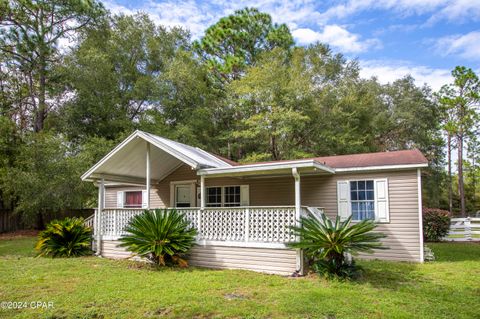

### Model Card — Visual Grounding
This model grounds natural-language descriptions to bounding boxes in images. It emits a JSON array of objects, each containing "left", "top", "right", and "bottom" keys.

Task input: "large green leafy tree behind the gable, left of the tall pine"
[{"left": 62, "top": 13, "right": 188, "bottom": 139}]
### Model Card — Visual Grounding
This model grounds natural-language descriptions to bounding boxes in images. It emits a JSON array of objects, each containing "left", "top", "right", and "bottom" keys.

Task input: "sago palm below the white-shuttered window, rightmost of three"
[{"left": 289, "top": 214, "right": 388, "bottom": 277}]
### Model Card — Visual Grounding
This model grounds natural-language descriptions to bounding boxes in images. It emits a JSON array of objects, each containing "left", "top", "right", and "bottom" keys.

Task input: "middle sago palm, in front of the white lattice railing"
[{"left": 120, "top": 209, "right": 197, "bottom": 267}]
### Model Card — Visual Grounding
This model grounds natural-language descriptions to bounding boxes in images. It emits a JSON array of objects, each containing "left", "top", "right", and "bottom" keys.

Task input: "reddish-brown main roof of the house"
[{"left": 213, "top": 149, "right": 428, "bottom": 168}]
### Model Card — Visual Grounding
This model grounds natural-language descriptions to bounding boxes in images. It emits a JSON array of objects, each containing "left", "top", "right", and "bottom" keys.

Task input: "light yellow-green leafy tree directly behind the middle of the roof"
[{"left": 230, "top": 49, "right": 311, "bottom": 161}]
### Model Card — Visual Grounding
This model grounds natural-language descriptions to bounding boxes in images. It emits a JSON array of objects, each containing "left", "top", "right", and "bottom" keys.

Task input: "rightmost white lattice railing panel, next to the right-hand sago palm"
[{"left": 248, "top": 207, "right": 296, "bottom": 243}]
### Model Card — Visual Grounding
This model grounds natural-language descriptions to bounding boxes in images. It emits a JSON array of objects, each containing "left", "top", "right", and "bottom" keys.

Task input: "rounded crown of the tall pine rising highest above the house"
[{"left": 194, "top": 8, "right": 294, "bottom": 83}]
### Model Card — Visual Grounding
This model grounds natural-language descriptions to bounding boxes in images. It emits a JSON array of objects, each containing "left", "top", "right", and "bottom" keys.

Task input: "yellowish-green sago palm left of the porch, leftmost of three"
[{"left": 35, "top": 217, "right": 92, "bottom": 257}]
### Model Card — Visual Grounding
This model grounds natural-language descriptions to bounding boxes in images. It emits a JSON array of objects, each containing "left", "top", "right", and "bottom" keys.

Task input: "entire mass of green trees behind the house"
[{"left": 0, "top": 0, "right": 480, "bottom": 226}]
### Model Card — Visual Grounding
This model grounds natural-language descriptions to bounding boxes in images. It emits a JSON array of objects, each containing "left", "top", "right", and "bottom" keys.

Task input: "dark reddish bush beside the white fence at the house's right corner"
[{"left": 423, "top": 207, "right": 450, "bottom": 241}]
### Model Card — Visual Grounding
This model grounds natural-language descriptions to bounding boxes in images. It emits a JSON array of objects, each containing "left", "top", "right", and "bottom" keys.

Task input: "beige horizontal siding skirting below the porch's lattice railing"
[{"left": 102, "top": 240, "right": 296, "bottom": 275}]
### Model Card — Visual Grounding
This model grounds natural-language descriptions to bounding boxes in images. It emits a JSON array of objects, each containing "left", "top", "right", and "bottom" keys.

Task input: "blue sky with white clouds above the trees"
[{"left": 103, "top": 0, "right": 480, "bottom": 90}]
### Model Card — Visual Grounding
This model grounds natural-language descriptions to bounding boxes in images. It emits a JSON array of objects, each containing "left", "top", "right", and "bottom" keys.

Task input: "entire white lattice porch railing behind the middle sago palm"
[{"left": 95, "top": 206, "right": 316, "bottom": 247}]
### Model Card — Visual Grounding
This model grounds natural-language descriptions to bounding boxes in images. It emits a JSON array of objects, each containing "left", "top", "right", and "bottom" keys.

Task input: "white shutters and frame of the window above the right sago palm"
[{"left": 337, "top": 177, "right": 390, "bottom": 224}]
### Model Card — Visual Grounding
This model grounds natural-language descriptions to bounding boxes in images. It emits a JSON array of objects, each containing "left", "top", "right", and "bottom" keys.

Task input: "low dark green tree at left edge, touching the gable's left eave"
[{"left": 0, "top": 131, "right": 113, "bottom": 229}]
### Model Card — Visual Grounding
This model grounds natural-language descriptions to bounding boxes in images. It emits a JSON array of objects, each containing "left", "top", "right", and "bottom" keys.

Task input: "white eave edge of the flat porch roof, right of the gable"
[{"left": 197, "top": 160, "right": 335, "bottom": 177}]
